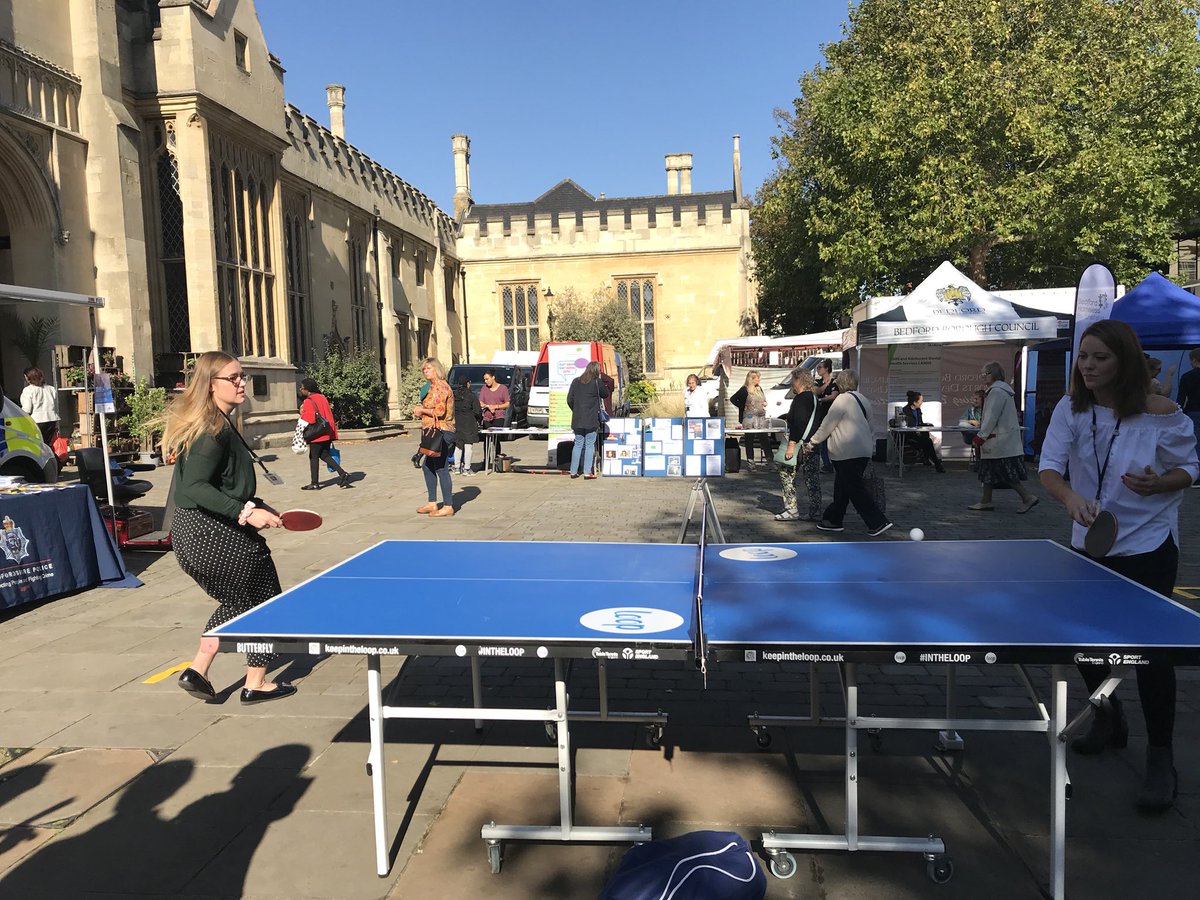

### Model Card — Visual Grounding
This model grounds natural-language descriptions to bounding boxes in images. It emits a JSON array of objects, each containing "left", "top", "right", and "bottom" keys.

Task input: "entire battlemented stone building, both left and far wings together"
[{"left": 0, "top": 0, "right": 752, "bottom": 442}]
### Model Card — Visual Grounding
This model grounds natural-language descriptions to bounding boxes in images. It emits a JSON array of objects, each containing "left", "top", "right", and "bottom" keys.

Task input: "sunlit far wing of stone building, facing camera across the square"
[{"left": 452, "top": 134, "right": 755, "bottom": 385}]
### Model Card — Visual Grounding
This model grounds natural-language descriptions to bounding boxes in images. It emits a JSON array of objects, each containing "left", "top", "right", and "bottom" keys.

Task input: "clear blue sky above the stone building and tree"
[{"left": 257, "top": 0, "right": 848, "bottom": 215}]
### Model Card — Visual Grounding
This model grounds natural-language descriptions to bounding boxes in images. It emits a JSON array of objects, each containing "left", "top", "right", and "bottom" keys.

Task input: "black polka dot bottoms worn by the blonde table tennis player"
[{"left": 170, "top": 509, "right": 281, "bottom": 668}]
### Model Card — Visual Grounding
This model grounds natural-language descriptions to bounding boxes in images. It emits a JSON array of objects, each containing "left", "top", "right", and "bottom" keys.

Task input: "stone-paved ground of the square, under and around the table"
[{"left": 0, "top": 437, "right": 1200, "bottom": 900}]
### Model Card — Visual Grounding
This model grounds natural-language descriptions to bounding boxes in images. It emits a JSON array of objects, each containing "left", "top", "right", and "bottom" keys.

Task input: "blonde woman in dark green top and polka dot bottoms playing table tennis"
[{"left": 162, "top": 350, "right": 295, "bottom": 703}]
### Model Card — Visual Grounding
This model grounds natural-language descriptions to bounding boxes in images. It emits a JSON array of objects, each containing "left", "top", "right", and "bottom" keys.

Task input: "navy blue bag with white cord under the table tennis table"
[{"left": 599, "top": 832, "right": 767, "bottom": 900}]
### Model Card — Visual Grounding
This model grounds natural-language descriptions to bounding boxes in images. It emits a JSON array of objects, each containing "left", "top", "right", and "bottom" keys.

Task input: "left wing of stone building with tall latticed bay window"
[{"left": 0, "top": 0, "right": 466, "bottom": 438}]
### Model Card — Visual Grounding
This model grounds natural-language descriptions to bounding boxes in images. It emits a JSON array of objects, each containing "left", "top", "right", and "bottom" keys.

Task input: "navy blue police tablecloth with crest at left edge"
[{"left": 0, "top": 485, "right": 142, "bottom": 610}]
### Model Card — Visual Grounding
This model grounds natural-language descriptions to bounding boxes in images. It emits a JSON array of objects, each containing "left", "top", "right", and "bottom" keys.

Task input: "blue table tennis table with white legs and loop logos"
[{"left": 206, "top": 528, "right": 1200, "bottom": 898}]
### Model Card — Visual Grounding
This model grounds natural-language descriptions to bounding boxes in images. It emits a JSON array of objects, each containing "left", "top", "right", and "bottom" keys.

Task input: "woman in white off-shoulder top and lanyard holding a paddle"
[{"left": 1040, "top": 319, "right": 1200, "bottom": 811}]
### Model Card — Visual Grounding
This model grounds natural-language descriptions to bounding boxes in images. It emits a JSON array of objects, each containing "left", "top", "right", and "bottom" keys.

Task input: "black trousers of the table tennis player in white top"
[{"left": 1079, "top": 535, "right": 1180, "bottom": 746}]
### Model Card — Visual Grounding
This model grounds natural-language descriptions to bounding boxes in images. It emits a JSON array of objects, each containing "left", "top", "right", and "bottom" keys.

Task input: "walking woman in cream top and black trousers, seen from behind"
[{"left": 804, "top": 368, "right": 892, "bottom": 538}]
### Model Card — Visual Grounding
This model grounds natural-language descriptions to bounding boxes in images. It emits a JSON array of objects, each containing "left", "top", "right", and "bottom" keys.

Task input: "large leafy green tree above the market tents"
[{"left": 754, "top": 0, "right": 1200, "bottom": 312}]
